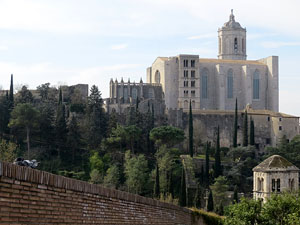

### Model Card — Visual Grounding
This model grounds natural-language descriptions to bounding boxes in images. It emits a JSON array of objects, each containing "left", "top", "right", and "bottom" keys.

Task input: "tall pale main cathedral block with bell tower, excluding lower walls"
[{"left": 147, "top": 12, "right": 279, "bottom": 112}]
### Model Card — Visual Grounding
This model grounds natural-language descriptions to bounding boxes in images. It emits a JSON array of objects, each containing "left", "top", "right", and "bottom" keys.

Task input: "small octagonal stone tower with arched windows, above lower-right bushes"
[{"left": 253, "top": 155, "right": 299, "bottom": 202}]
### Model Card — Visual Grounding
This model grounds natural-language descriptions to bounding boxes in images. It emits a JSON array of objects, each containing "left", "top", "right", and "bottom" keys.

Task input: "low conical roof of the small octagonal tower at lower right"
[{"left": 253, "top": 155, "right": 299, "bottom": 172}]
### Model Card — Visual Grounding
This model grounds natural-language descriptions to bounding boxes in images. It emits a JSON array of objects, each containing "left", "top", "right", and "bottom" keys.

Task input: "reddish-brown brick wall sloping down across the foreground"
[{"left": 0, "top": 162, "right": 204, "bottom": 225}]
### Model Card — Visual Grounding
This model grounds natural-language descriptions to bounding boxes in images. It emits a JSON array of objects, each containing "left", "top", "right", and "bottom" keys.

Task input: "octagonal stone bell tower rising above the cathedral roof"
[{"left": 218, "top": 10, "right": 247, "bottom": 60}]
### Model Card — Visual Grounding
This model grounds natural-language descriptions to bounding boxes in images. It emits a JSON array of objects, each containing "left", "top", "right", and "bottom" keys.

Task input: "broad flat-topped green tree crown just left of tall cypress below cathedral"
[{"left": 150, "top": 126, "right": 185, "bottom": 147}]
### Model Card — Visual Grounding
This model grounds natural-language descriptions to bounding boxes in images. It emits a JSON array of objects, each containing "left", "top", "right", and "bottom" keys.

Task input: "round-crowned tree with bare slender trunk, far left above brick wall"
[{"left": 9, "top": 103, "right": 39, "bottom": 159}]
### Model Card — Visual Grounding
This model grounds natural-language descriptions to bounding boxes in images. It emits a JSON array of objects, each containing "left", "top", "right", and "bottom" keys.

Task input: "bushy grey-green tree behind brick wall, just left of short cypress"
[{"left": 125, "top": 151, "right": 149, "bottom": 194}]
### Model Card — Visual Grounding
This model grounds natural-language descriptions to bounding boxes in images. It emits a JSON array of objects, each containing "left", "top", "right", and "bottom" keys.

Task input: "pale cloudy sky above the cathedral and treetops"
[{"left": 0, "top": 0, "right": 300, "bottom": 116}]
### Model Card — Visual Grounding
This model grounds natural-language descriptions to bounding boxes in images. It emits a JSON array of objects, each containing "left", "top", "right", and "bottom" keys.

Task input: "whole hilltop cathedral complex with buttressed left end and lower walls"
[{"left": 106, "top": 11, "right": 300, "bottom": 149}]
